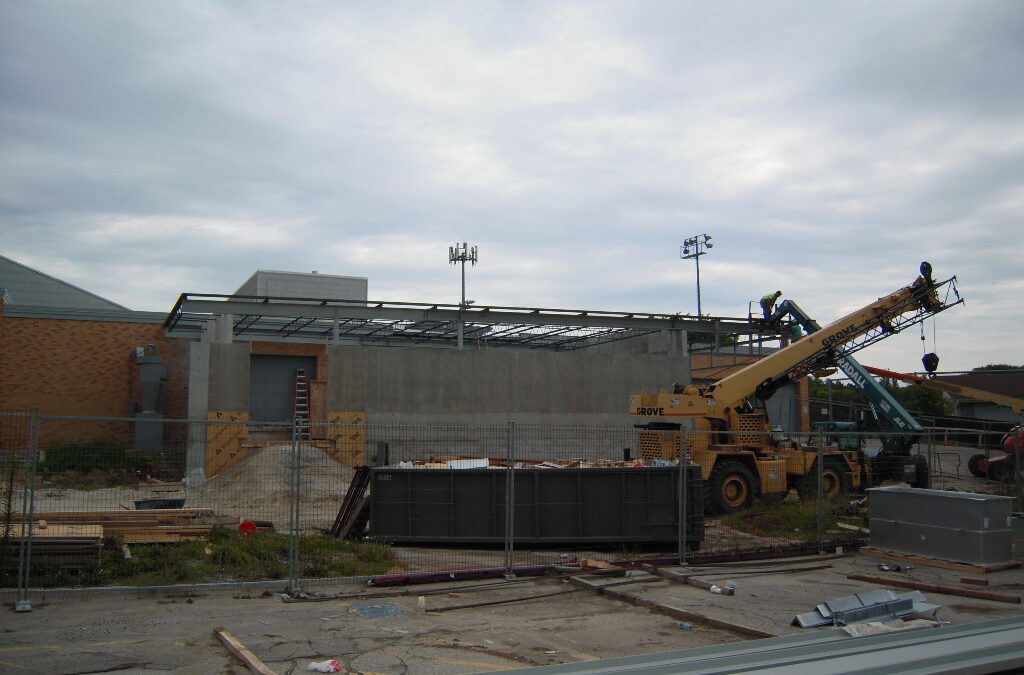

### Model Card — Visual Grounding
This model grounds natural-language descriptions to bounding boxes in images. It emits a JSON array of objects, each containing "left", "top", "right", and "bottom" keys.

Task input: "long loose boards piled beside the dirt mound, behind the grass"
[{"left": 14, "top": 509, "right": 216, "bottom": 544}]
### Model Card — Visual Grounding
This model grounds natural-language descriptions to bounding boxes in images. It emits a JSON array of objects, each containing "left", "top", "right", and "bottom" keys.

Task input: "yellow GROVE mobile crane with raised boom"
[{"left": 630, "top": 262, "right": 963, "bottom": 512}]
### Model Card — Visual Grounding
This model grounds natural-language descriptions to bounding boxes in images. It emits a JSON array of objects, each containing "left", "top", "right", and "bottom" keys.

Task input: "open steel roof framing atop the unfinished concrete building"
[{"left": 164, "top": 293, "right": 772, "bottom": 350}]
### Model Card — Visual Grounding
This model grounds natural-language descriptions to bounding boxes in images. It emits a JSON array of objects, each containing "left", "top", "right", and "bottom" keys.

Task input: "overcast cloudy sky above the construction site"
[{"left": 0, "top": 0, "right": 1024, "bottom": 371}]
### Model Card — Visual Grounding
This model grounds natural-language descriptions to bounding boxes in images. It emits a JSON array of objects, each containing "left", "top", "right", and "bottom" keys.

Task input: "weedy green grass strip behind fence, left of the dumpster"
[{"left": 14, "top": 526, "right": 395, "bottom": 588}]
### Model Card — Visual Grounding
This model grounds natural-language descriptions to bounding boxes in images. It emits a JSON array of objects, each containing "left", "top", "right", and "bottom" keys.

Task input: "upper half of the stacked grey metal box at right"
[{"left": 867, "top": 487, "right": 1014, "bottom": 531}]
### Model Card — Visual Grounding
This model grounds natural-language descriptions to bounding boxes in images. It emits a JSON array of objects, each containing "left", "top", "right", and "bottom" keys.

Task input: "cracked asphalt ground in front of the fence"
[{"left": 0, "top": 554, "right": 1024, "bottom": 675}]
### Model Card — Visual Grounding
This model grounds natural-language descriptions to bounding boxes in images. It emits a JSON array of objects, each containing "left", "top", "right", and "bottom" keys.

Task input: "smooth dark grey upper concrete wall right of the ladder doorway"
[{"left": 327, "top": 345, "right": 689, "bottom": 425}]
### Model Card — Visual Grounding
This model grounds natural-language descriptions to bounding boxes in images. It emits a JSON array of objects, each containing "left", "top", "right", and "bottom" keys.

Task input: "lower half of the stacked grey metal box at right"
[{"left": 870, "top": 518, "right": 1012, "bottom": 564}]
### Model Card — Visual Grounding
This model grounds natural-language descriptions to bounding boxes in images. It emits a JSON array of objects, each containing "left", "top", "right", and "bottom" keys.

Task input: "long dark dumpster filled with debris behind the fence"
[{"left": 370, "top": 466, "right": 703, "bottom": 550}]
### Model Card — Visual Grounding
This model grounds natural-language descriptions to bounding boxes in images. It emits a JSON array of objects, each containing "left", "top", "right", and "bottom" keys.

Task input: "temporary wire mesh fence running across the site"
[{"left": 0, "top": 412, "right": 1024, "bottom": 601}]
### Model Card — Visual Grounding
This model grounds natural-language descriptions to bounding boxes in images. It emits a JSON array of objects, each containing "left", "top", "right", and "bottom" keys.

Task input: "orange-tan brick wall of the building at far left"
[{"left": 0, "top": 314, "right": 188, "bottom": 447}]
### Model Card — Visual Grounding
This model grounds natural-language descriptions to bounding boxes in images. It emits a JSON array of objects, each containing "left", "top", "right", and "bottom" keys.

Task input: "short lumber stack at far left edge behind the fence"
[{"left": 0, "top": 521, "right": 103, "bottom": 569}]
